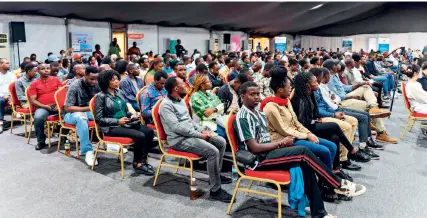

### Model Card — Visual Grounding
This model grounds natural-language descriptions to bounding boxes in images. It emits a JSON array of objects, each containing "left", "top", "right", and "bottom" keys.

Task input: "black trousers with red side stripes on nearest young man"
[{"left": 256, "top": 146, "right": 341, "bottom": 217}]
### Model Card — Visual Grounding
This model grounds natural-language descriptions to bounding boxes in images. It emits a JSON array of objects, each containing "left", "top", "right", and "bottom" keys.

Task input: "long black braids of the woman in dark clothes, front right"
[{"left": 291, "top": 72, "right": 319, "bottom": 127}]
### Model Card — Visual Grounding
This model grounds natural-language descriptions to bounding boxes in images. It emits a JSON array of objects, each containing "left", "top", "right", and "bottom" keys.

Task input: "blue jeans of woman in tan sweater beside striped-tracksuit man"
[{"left": 294, "top": 138, "right": 337, "bottom": 168}]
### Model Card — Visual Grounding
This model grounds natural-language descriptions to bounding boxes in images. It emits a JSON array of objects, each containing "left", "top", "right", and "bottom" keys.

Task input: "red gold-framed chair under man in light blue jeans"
[{"left": 55, "top": 86, "right": 95, "bottom": 159}]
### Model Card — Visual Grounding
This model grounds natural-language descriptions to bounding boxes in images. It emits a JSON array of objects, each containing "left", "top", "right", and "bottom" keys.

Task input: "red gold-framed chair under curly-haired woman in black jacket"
[{"left": 89, "top": 96, "right": 134, "bottom": 179}]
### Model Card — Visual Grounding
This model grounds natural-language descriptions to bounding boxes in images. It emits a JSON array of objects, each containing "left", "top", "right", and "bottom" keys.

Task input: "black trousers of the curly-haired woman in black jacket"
[{"left": 104, "top": 125, "right": 154, "bottom": 163}]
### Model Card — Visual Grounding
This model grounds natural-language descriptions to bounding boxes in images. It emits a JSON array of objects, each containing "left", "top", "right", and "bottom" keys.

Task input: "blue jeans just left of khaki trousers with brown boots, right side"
[{"left": 338, "top": 108, "right": 371, "bottom": 142}]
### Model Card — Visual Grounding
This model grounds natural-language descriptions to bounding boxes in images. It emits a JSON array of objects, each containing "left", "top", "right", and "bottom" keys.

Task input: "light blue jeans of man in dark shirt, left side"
[{"left": 64, "top": 111, "right": 93, "bottom": 155}]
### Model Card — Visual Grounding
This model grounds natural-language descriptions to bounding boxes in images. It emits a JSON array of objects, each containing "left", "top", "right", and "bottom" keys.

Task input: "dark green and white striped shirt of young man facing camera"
[{"left": 234, "top": 105, "right": 271, "bottom": 152}]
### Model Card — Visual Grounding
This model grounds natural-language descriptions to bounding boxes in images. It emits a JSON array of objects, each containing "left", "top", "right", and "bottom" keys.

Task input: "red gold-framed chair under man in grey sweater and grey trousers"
[{"left": 152, "top": 99, "right": 201, "bottom": 186}]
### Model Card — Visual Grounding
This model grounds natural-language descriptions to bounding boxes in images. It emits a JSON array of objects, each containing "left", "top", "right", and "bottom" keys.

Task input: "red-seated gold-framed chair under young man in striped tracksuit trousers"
[{"left": 226, "top": 114, "right": 290, "bottom": 218}]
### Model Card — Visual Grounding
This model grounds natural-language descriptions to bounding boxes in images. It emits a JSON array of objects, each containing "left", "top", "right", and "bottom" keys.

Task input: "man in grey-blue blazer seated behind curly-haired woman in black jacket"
[{"left": 120, "top": 62, "right": 144, "bottom": 111}]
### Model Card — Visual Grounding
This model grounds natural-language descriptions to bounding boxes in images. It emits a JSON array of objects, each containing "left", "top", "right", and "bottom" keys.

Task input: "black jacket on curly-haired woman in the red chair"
[{"left": 95, "top": 89, "right": 131, "bottom": 133}]
